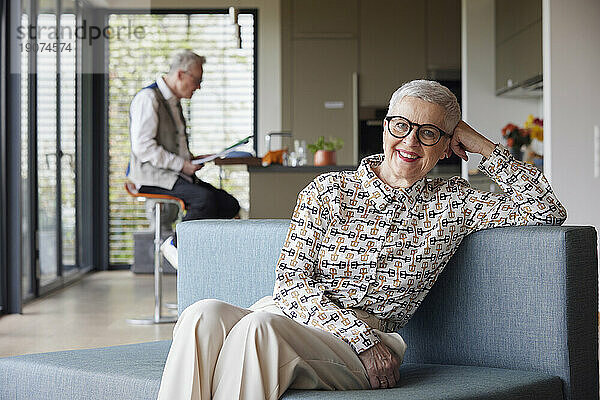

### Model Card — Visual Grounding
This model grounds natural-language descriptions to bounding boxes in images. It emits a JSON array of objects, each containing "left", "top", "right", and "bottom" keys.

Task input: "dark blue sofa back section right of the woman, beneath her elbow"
[{"left": 400, "top": 227, "right": 598, "bottom": 399}]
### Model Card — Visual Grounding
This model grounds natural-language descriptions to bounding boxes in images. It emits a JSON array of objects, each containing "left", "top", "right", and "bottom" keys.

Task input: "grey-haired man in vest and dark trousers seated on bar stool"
[{"left": 127, "top": 50, "right": 240, "bottom": 261}]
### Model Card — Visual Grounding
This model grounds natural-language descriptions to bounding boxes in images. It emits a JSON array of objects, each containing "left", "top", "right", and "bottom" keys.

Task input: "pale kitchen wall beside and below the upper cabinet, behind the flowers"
[{"left": 461, "top": 0, "right": 542, "bottom": 178}]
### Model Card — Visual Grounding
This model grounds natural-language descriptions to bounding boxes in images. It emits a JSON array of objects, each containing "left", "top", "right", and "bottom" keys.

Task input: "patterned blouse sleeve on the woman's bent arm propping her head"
[{"left": 460, "top": 145, "right": 567, "bottom": 232}]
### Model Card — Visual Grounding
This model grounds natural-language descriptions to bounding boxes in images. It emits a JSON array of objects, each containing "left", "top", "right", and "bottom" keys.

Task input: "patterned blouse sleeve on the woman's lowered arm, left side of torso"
[{"left": 273, "top": 181, "right": 379, "bottom": 353}]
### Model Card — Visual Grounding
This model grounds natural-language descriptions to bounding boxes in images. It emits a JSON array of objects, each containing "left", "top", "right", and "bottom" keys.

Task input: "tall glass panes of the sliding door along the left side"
[{"left": 21, "top": 0, "right": 79, "bottom": 298}]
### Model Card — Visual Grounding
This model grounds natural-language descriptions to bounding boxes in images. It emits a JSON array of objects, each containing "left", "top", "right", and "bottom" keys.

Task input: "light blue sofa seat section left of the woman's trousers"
[{"left": 0, "top": 340, "right": 171, "bottom": 400}]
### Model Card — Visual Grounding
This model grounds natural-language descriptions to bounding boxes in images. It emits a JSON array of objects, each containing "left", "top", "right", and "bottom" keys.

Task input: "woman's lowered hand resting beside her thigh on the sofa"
[{"left": 358, "top": 342, "right": 400, "bottom": 389}]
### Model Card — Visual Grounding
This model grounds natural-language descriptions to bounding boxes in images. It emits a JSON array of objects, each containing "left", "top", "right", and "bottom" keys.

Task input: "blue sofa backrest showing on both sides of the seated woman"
[{"left": 177, "top": 220, "right": 598, "bottom": 399}]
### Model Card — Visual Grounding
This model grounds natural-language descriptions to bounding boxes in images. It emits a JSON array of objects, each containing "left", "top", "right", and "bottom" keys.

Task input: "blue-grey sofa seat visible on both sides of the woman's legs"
[{"left": 0, "top": 341, "right": 563, "bottom": 400}]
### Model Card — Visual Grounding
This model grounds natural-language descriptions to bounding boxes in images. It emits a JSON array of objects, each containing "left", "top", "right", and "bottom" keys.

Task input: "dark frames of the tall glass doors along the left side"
[{"left": 0, "top": 0, "right": 97, "bottom": 314}]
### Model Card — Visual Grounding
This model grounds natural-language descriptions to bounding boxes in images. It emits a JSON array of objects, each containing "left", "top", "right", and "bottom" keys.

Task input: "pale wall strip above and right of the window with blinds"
[{"left": 102, "top": 0, "right": 282, "bottom": 155}]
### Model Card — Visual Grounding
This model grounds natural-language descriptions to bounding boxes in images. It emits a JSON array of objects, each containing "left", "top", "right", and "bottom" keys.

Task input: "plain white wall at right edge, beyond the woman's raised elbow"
[{"left": 542, "top": 0, "right": 600, "bottom": 244}]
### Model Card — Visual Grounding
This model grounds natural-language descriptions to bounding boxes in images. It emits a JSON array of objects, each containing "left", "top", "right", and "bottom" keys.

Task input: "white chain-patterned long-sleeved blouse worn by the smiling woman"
[{"left": 273, "top": 145, "right": 567, "bottom": 353}]
